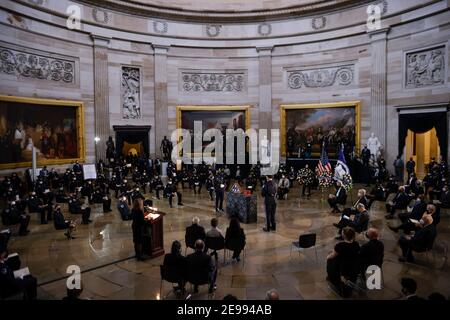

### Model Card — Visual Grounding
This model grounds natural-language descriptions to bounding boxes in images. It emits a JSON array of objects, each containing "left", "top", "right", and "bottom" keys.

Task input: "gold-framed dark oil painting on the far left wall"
[{"left": 0, "top": 95, "right": 85, "bottom": 169}]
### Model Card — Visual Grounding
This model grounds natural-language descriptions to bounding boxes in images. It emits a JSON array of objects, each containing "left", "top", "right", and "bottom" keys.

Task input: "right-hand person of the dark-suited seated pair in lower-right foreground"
[{"left": 359, "top": 228, "right": 384, "bottom": 276}]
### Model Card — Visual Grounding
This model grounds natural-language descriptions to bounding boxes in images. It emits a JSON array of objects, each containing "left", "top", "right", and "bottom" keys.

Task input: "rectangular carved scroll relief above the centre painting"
[{"left": 181, "top": 72, "right": 245, "bottom": 92}]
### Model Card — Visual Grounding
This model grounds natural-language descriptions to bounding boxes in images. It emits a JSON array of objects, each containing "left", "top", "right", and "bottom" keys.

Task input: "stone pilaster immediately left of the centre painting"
[{"left": 153, "top": 45, "right": 170, "bottom": 156}]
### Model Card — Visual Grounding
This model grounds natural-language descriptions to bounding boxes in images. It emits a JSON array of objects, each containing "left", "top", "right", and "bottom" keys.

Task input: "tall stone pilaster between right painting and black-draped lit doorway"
[{"left": 368, "top": 28, "right": 389, "bottom": 151}]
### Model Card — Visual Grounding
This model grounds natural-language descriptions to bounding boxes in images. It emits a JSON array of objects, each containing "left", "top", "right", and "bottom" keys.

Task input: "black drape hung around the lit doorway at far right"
[{"left": 398, "top": 112, "right": 448, "bottom": 159}]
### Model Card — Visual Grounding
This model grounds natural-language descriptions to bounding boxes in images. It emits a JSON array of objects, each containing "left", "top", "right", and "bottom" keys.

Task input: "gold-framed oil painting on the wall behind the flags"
[{"left": 280, "top": 101, "right": 361, "bottom": 158}]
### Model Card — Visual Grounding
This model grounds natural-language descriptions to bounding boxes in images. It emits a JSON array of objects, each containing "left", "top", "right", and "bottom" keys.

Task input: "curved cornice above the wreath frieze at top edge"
[{"left": 79, "top": 0, "right": 373, "bottom": 21}]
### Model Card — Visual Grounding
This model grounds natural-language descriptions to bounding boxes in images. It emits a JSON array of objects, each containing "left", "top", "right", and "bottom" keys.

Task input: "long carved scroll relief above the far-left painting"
[{"left": 0, "top": 47, "right": 75, "bottom": 83}]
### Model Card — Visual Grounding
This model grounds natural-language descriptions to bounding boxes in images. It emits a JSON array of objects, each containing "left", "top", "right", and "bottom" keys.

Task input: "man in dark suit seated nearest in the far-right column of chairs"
[{"left": 399, "top": 215, "right": 436, "bottom": 262}]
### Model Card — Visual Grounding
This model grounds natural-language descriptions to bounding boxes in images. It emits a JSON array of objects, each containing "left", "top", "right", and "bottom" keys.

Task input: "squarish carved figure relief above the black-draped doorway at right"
[{"left": 405, "top": 45, "right": 447, "bottom": 89}]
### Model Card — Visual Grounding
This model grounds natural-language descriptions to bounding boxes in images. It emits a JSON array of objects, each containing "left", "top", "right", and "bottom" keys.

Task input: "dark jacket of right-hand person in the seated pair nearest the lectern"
[{"left": 186, "top": 251, "right": 215, "bottom": 284}]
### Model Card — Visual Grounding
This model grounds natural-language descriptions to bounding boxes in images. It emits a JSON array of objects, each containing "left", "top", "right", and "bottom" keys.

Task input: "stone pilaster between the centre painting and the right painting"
[{"left": 256, "top": 47, "right": 273, "bottom": 134}]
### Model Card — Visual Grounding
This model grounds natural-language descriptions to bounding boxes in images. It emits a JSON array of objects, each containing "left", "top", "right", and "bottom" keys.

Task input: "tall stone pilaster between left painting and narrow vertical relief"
[{"left": 90, "top": 35, "right": 110, "bottom": 161}]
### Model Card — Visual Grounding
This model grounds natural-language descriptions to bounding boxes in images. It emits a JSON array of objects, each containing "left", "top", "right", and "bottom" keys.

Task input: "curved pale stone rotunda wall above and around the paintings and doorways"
[{"left": 0, "top": 0, "right": 450, "bottom": 172}]
